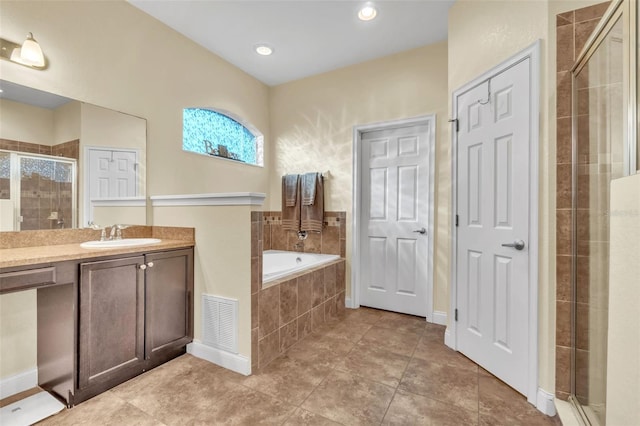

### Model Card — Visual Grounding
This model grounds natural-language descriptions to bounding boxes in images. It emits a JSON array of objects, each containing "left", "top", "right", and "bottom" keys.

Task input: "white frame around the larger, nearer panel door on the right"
[{"left": 445, "top": 40, "right": 548, "bottom": 411}]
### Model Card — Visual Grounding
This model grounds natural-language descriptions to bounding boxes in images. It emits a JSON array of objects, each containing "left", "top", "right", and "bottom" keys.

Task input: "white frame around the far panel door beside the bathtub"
[{"left": 346, "top": 114, "right": 437, "bottom": 322}]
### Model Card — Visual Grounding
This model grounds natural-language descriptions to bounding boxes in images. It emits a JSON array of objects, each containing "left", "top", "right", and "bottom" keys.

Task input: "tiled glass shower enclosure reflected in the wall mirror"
[{"left": 0, "top": 151, "right": 77, "bottom": 231}]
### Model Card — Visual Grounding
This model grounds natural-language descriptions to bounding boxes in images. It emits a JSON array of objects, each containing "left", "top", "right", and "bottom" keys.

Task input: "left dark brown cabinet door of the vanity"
[{"left": 78, "top": 256, "right": 144, "bottom": 389}]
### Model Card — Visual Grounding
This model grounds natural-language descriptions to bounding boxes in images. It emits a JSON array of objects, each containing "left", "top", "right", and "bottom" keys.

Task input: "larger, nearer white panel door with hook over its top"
[{"left": 456, "top": 59, "right": 535, "bottom": 394}]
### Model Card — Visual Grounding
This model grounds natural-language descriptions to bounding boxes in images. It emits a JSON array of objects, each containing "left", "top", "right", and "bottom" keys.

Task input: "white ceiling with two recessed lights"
[{"left": 129, "top": 0, "right": 455, "bottom": 86}]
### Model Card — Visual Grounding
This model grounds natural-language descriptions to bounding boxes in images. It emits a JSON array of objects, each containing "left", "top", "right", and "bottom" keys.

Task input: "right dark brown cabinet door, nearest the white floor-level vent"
[{"left": 145, "top": 249, "right": 193, "bottom": 359}]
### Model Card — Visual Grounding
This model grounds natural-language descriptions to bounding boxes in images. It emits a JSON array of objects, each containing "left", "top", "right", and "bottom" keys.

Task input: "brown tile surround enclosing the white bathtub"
[{"left": 251, "top": 211, "right": 346, "bottom": 372}]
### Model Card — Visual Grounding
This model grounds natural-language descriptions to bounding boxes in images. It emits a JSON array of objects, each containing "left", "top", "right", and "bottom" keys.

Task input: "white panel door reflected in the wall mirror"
[{"left": 89, "top": 149, "right": 137, "bottom": 200}]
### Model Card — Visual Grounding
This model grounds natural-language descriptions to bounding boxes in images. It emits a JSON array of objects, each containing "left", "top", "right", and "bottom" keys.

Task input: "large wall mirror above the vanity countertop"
[{"left": 0, "top": 80, "right": 147, "bottom": 231}]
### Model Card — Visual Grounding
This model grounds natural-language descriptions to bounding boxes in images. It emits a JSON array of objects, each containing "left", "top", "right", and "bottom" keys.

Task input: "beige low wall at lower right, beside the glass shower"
[{"left": 607, "top": 174, "right": 640, "bottom": 425}]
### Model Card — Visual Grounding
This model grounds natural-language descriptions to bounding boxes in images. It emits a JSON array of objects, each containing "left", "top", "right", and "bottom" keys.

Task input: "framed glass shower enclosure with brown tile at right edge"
[{"left": 569, "top": 0, "right": 638, "bottom": 425}]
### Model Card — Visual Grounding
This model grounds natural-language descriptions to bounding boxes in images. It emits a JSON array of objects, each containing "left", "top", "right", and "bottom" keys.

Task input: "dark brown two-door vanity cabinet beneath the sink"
[{"left": 73, "top": 249, "right": 193, "bottom": 403}]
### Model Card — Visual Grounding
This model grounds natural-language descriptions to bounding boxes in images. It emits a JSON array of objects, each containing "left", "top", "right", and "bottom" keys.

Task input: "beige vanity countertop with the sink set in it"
[{"left": 0, "top": 239, "right": 194, "bottom": 268}]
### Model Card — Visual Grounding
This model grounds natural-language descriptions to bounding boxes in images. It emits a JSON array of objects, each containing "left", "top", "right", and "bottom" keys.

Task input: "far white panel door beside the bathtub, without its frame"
[{"left": 360, "top": 124, "right": 432, "bottom": 317}]
